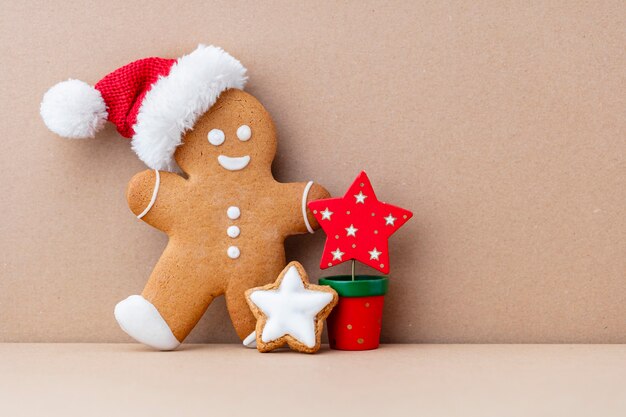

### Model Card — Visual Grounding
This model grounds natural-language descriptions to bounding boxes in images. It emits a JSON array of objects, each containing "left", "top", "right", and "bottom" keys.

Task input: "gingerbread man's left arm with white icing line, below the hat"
[{"left": 126, "top": 170, "right": 185, "bottom": 231}]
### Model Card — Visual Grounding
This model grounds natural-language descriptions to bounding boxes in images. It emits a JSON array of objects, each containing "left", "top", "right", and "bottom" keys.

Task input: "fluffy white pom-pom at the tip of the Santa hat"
[{"left": 40, "top": 79, "right": 108, "bottom": 139}]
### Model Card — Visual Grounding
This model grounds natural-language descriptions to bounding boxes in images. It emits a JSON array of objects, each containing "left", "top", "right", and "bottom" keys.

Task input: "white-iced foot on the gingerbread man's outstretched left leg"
[{"left": 115, "top": 295, "right": 180, "bottom": 350}]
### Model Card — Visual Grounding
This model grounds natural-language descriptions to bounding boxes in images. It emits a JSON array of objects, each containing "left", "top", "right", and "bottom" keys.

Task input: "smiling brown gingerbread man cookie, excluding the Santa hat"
[{"left": 116, "top": 90, "right": 328, "bottom": 349}]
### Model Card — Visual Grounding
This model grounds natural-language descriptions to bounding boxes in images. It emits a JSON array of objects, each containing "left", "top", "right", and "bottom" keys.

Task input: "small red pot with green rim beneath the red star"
[{"left": 319, "top": 275, "right": 389, "bottom": 350}]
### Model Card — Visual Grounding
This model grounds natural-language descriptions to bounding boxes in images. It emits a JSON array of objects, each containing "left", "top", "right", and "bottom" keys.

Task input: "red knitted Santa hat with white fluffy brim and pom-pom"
[{"left": 41, "top": 45, "right": 247, "bottom": 171}]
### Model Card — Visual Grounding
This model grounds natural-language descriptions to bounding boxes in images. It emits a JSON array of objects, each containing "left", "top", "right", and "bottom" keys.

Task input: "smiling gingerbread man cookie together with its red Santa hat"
[{"left": 41, "top": 45, "right": 329, "bottom": 350}]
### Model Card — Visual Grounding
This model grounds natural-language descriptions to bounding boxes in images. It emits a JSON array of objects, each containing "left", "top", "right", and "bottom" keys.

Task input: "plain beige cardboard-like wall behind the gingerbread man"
[{"left": 0, "top": 1, "right": 626, "bottom": 342}]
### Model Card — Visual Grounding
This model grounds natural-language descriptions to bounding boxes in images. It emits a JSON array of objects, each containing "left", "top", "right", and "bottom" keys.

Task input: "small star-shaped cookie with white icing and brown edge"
[{"left": 246, "top": 261, "right": 338, "bottom": 353}]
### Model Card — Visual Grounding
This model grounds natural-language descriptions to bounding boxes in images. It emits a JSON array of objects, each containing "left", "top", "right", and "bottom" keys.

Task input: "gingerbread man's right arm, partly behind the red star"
[{"left": 283, "top": 181, "right": 330, "bottom": 235}]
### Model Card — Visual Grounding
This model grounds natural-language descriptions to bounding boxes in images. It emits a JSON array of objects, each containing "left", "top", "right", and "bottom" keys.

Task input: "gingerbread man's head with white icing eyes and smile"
[{"left": 175, "top": 89, "right": 276, "bottom": 180}]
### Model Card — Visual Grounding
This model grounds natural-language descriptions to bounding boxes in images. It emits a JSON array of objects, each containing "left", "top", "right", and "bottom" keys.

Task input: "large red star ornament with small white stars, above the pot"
[{"left": 308, "top": 171, "right": 413, "bottom": 274}]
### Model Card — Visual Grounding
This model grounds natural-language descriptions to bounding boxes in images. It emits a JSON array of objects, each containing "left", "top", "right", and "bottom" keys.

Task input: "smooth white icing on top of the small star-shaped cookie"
[{"left": 250, "top": 266, "right": 333, "bottom": 348}]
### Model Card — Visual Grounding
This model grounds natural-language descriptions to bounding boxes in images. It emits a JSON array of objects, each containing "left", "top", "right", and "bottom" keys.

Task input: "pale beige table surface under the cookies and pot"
[{"left": 0, "top": 344, "right": 626, "bottom": 417}]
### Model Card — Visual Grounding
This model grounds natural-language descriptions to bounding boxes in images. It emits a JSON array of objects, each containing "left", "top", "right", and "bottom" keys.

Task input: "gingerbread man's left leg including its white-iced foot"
[{"left": 115, "top": 242, "right": 223, "bottom": 350}]
